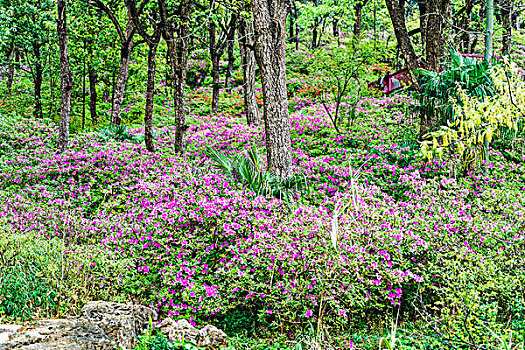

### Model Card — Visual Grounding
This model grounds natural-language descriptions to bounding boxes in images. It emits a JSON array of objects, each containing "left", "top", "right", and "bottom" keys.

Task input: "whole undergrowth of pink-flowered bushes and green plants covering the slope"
[{"left": 0, "top": 82, "right": 525, "bottom": 349}]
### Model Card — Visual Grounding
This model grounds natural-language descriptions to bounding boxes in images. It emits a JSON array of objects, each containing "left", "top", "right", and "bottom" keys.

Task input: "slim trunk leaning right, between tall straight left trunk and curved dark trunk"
[{"left": 111, "top": 16, "right": 135, "bottom": 125}]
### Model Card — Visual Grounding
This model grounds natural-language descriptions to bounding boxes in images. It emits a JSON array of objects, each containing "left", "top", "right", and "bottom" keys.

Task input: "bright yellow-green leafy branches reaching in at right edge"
[{"left": 421, "top": 63, "right": 525, "bottom": 170}]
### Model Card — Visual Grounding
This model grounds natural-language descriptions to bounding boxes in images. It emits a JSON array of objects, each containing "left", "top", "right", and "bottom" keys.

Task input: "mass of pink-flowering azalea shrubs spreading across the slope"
[{"left": 0, "top": 89, "right": 525, "bottom": 346}]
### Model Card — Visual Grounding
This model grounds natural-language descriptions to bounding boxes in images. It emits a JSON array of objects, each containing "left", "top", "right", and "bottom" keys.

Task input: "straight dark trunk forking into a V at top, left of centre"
[{"left": 158, "top": 0, "right": 193, "bottom": 153}]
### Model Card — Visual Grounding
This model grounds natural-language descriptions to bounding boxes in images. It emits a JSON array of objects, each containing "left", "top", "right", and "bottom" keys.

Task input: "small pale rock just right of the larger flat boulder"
[{"left": 157, "top": 318, "right": 228, "bottom": 350}]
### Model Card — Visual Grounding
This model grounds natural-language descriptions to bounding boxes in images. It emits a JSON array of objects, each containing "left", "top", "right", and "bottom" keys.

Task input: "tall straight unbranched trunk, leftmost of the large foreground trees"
[{"left": 57, "top": 0, "right": 73, "bottom": 152}]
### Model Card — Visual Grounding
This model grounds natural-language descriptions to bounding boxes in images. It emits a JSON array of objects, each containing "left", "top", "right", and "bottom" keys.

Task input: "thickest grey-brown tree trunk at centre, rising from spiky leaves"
[{"left": 253, "top": 0, "right": 293, "bottom": 178}]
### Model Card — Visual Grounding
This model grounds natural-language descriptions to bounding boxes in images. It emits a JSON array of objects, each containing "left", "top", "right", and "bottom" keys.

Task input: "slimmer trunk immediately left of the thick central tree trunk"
[{"left": 239, "top": 14, "right": 259, "bottom": 125}]
